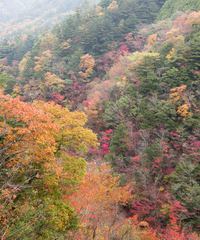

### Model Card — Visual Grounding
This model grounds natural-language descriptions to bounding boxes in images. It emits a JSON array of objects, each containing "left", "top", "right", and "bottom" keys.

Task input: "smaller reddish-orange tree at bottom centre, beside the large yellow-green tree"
[{"left": 70, "top": 164, "right": 131, "bottom": 240}]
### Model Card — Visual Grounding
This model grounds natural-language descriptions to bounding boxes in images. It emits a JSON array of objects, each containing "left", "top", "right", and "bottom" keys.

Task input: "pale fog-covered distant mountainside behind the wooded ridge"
[{"left": 0, "top": 0, "right": 98, "bottom": 41}]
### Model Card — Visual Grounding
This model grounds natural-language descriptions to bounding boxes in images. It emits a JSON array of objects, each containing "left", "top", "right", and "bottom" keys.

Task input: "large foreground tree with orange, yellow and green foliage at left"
[{"left": 0, "top": 93, "right": 96, "bottom": 239}]
